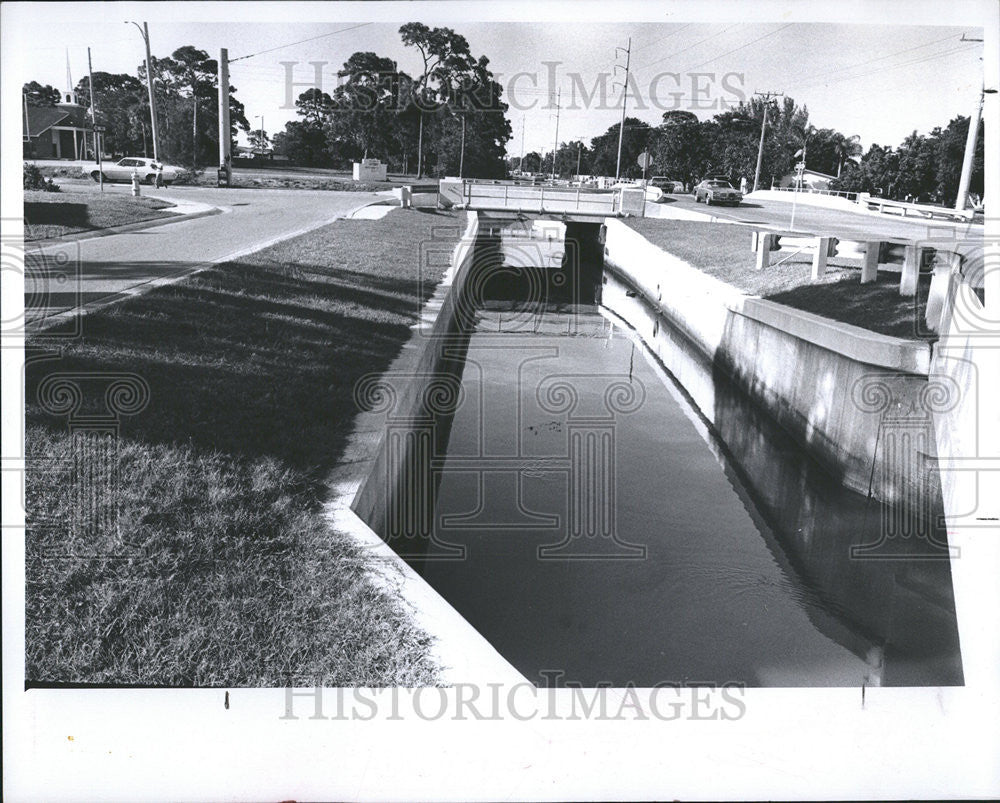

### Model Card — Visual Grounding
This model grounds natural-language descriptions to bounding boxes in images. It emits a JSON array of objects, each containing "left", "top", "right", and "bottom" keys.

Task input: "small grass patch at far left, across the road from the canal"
[{"left": 24, "top": 190, "right": 173, "bottom": 242}]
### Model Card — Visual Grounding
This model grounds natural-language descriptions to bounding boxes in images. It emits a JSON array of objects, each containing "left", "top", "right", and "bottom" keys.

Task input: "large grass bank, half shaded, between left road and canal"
[{"left": 26, "top": 210, "right": 462, "bottom": 686}]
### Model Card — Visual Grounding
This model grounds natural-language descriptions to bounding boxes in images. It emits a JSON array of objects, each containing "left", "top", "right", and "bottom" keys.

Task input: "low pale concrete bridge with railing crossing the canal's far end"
[{"left": 439, "top": 179, "right": 646, "bottom": 223}]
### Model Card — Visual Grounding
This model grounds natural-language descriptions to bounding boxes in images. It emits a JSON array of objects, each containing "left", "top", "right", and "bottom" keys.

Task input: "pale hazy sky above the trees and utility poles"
[{"left": 3, "top": 1, "right": 983, "bottom": 155}]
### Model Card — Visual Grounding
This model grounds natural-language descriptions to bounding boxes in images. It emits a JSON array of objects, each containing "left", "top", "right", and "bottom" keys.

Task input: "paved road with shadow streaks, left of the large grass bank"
[{"left": 24, "top": 185, "right": 379, "bottom": 330}]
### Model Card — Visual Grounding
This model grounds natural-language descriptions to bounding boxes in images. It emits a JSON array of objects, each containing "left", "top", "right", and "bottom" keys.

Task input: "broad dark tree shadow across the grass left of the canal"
[{"left": 26, "top": 254, "right": 432, "bottom": 479}]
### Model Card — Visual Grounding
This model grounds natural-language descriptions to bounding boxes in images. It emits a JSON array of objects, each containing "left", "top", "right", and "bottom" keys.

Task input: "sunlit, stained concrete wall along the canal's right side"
[{"left": 605, "top": 219, "right": 951, "bottom": 503}]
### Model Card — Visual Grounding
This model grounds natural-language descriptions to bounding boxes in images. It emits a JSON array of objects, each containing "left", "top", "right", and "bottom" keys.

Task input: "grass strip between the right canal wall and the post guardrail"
[{"left": 626, "top": 218, "right": 930, "bottom": 338}]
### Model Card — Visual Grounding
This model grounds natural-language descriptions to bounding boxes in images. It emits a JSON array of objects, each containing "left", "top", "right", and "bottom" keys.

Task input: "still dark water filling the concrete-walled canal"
[{"left": 376, "top": 218, "right": 962, "bottom": 687}]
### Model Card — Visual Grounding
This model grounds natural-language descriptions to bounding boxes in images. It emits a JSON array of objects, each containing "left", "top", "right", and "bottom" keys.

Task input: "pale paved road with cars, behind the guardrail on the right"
[{"left": 657, "top": 195, "right": 983, "bottom": 247}]
